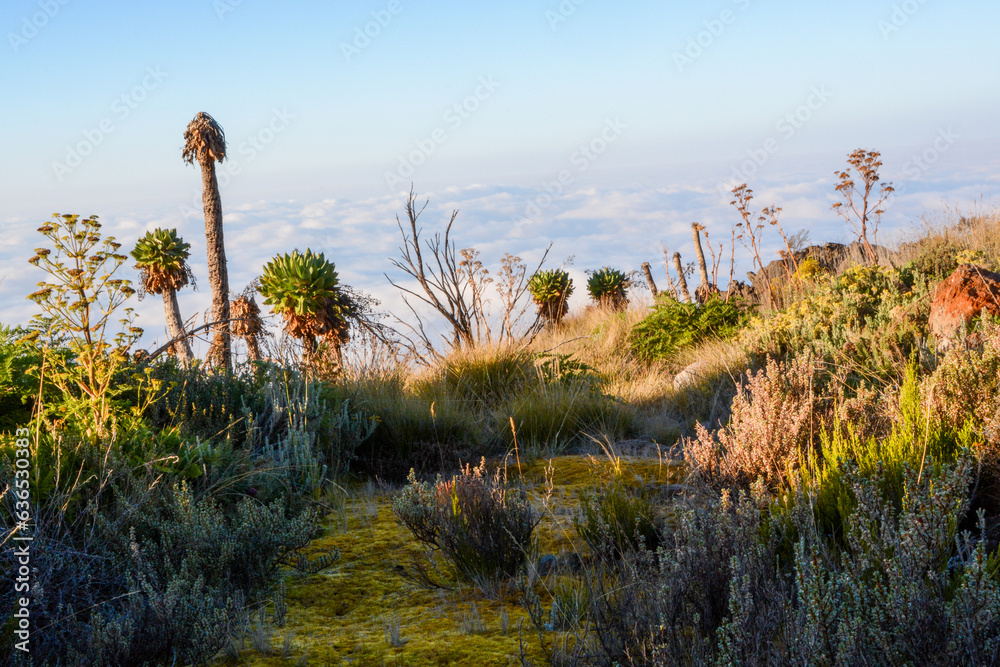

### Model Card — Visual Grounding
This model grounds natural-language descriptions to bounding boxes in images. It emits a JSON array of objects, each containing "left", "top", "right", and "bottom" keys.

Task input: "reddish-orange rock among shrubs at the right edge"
[{"left": 927, "top": 264, "right": 1000, "bottom": 349}]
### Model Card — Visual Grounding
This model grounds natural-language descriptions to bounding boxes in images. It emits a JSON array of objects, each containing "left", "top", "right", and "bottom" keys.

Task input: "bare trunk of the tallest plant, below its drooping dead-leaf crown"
[{"left": 201, "top": 156, "right": 232, "bottom": 370}]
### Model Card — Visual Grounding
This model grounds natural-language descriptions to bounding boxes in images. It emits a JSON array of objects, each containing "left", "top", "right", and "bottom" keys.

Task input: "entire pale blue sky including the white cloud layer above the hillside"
[{"left": 0, "top": 0, "right": 1000, "bottom": 350}]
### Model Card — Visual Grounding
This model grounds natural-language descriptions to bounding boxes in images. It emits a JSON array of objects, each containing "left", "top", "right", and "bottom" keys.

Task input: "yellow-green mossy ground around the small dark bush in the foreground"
[{"left": 220, "top": 456, "right": 676, "bottom": 667}]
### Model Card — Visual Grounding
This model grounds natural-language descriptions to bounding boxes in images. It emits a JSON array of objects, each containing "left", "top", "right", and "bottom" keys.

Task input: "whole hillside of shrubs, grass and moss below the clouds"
[{"left": 0, "top": 187, "right": 1000, "bottom": 667}]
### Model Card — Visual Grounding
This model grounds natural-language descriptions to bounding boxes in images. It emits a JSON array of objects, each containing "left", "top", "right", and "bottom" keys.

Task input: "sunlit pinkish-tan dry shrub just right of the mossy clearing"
[{"left": 684, "top": 356, "right": 816, "bottom": 486}]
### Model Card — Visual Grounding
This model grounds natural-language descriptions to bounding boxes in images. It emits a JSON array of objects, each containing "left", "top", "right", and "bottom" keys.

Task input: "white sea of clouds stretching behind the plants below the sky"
[{"left": 0, "top": 145, "right": 1000, "bottom": 354}]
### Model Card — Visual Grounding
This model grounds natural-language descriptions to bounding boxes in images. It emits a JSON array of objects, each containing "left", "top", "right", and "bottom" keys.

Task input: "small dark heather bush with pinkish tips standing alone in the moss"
[{"left": 392, "top": 460, "right": 538, "bottom": 585}]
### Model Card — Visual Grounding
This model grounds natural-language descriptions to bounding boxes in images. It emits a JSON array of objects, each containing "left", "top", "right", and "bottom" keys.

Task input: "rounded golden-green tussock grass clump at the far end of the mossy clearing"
[{"left": 340, "top": 334, "right": 634, "bottom": 479}]
